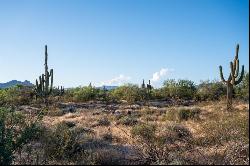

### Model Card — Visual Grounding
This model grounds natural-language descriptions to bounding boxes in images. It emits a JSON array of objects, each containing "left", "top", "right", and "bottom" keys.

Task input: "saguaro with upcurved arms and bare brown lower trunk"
[{"left": 219, "top": 44, "right": 244, "bottom": 111}]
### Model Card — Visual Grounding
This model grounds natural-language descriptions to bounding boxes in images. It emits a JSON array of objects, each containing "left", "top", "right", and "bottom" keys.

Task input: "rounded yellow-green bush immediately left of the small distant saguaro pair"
[{"left": 110, "top": 84, "right": 143, "bottom": 104}]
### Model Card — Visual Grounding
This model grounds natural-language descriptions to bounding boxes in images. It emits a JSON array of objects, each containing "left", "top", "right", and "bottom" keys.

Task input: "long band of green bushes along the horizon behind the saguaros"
[{"left": 0, "top": 72, "right": 249, "bottom": 105}]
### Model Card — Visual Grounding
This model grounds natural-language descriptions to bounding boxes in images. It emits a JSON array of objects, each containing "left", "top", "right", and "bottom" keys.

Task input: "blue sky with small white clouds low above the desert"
[{"left": 0, "top": 0, "right": 249, "bottom": 87}]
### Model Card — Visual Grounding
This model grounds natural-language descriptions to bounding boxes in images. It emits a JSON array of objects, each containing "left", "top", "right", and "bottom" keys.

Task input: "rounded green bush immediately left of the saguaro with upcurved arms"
[{"left": 196, "top": 80, "right": 227, "bottom": 101}]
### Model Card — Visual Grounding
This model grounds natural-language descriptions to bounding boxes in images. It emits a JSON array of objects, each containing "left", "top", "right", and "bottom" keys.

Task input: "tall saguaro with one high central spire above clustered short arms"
[{"left": 35, "top": 45, "right": 53, "bottom": 106}]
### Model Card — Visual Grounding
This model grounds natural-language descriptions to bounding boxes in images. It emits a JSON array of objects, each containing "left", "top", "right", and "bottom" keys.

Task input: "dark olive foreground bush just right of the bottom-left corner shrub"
[{"left": 40, "top": 121, "right": 97, "bottom": 163}]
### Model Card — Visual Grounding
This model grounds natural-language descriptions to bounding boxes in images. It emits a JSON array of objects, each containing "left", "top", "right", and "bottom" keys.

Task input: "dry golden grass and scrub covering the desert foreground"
[{"left": 13, "top": 103, "right": 249, "bottom": 165}]
